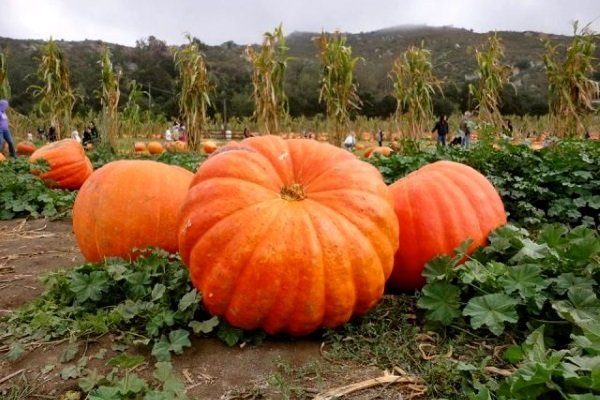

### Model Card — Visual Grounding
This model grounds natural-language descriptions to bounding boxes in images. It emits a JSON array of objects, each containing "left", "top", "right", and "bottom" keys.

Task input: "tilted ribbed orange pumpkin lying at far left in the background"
[{"left": 29, "top": 139, "right": 93, "bottom": 189}]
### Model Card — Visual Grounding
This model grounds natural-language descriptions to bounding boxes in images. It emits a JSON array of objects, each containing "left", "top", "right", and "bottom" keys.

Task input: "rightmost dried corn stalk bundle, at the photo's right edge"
[{"left": 543, "top": 22, "right": 600, "bottom": 137}]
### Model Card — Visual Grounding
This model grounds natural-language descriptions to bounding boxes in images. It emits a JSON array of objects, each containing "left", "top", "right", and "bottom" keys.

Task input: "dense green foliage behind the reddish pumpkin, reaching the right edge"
[{"left": 368, "top": 141, "right": 600, "bottom": 227}]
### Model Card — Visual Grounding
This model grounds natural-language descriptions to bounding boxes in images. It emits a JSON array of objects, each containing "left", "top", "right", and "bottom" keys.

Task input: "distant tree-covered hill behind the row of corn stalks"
[{"left": 0, "top": 26, "right": 592, "bottom": 116}]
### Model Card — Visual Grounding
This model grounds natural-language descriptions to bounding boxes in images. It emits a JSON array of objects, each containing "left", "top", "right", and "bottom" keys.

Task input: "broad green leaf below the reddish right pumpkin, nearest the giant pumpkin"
[{"left": 417, "top": 282, "right": 460, "bottom": 325}]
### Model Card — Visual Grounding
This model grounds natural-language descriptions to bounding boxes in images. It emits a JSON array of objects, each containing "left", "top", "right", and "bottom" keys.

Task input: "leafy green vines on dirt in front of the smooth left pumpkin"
[{"left": 0, "top": 251, "right": 263, "bottom": 361}]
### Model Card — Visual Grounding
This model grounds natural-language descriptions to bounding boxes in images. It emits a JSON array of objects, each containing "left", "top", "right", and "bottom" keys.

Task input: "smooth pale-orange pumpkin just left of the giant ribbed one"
[{"left": 73, "top": 160, "right": 194, "bottom": 262}]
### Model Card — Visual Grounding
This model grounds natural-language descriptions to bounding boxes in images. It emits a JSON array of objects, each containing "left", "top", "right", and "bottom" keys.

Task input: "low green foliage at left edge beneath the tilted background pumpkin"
[{"left": 0, "top": 158, "right": 75, "bottom": 220}]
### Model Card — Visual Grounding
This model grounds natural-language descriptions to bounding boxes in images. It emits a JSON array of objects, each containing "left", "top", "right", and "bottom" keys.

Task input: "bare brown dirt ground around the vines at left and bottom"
[{"left": 0, "top": 220, "right": 412, "bottom": 400}]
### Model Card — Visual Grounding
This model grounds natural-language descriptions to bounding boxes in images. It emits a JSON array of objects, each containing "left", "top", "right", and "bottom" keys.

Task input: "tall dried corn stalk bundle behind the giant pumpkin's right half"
[{"left": 313, "top": 32, "right": 362, "bottom": 146}]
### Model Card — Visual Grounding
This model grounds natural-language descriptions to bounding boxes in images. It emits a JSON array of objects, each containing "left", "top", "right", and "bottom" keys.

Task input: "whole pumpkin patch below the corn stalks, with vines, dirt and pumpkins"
[{"left": 0, "top": 137, "right": 600, "bottom": 400}]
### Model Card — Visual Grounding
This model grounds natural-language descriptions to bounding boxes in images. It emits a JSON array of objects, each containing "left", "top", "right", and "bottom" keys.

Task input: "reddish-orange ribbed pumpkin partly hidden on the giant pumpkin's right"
[{"left": 388, "top": 161, "right": 506, "bottom": 291}]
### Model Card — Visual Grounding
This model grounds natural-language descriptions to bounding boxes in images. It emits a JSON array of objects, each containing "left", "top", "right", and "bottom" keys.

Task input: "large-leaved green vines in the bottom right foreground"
[{"left": 418, "top": 225, "right": 600, "bottom": 399}]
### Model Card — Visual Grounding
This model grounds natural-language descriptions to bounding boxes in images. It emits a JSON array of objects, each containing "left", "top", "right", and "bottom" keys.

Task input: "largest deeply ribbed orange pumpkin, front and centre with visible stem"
[{"left": 179, "top": 136, "right": 398, "bottom": 336}]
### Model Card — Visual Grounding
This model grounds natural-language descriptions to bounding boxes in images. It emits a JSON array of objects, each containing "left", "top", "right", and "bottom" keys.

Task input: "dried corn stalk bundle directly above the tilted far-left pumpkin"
[{"left": 29, "top": 38, "right": 75, "bottom": 139}]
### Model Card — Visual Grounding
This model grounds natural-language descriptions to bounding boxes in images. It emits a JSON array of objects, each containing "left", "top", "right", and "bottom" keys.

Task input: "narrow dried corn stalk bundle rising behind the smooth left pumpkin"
[{"left": 100, "top": 47, "right": 121, "bottom": 150}]
